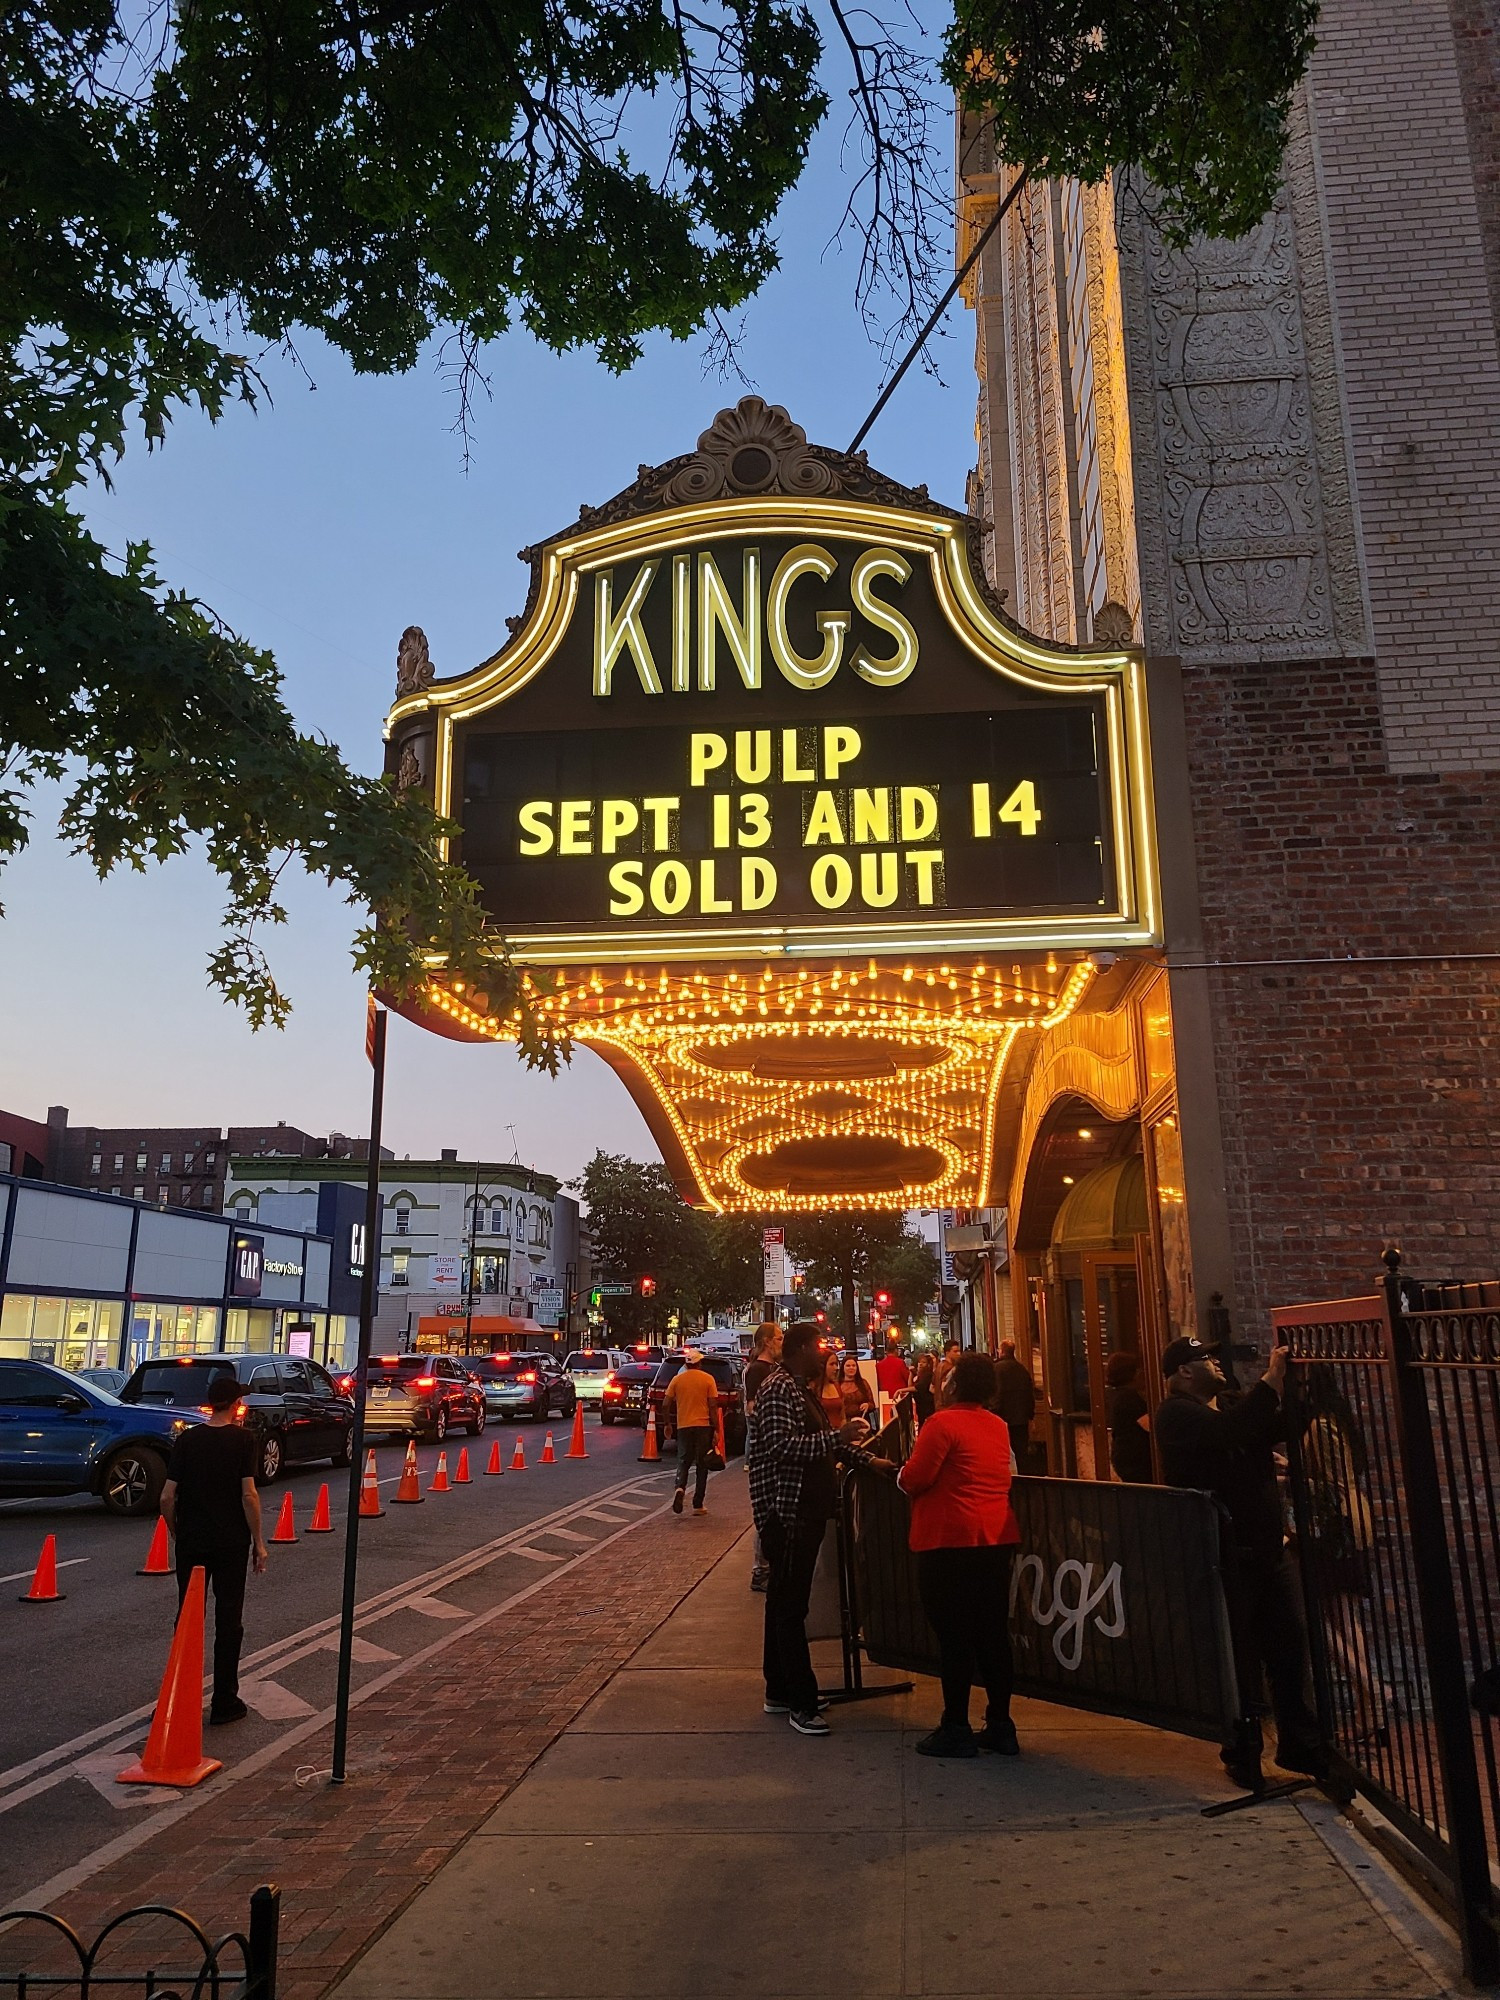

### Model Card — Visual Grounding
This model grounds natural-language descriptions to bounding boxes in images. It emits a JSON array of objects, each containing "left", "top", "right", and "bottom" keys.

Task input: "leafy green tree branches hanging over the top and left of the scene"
[{"left": 0, "top": 0, "right": 1312, "bottom": 1024}]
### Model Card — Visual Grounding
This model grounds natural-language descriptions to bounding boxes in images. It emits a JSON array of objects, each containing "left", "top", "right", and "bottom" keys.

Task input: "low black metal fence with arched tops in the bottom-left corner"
[{"left": 0, "top": 1888, "right": 282, "bottom": 2000}]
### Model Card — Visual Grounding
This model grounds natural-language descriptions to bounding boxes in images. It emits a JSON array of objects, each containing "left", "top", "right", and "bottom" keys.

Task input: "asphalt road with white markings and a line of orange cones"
[{"left": 0, "top": 1418, "right": 670, "bottom": 1910}]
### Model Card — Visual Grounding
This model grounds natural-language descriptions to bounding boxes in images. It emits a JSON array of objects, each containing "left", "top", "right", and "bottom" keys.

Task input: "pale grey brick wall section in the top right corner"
[{"left": 1308, "top": 0, "right": 1500, "bottom": 772}]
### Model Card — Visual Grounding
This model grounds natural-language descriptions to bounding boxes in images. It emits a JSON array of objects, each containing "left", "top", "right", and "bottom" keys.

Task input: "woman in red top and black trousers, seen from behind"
[{"left": 900, "top": 1354, "right": 1020, "bottom": 1756}]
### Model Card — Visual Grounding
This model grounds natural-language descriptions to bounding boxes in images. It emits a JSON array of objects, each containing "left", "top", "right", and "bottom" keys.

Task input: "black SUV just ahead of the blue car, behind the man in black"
[{"left": 120, "top": 1354, "right": 354, "bottom": 1484}]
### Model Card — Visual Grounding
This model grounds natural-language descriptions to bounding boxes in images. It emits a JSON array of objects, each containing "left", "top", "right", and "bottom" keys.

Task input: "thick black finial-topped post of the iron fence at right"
[{"left": 1382, "top": 1250, "right": 1500, "bottom": 1986}]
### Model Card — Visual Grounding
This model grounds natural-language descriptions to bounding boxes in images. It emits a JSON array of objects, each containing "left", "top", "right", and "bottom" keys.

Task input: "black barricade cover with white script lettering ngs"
[{"left": 846, "top": 1472, "right": 1238, "bottom": 1738}]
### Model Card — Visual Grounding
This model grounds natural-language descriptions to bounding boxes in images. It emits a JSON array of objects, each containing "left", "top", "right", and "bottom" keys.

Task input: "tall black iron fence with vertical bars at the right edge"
[{"left": 1272, "top": 1250, "right": 1500, "bottom": 1982}]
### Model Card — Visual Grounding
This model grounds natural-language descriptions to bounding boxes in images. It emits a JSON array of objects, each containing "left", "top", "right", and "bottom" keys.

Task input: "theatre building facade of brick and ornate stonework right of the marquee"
[{"left": 960, "top": 0, "right": 1500, "bottom": 1472}]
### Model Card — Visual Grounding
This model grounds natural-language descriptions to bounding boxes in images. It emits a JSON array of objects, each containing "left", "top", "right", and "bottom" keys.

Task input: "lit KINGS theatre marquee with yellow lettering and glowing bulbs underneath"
[{"left": 388, "top": 398, "right": 1158, "bottom": 1208}]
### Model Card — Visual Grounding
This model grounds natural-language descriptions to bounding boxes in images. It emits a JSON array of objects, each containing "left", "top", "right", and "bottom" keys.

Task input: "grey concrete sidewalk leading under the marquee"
[{"left": 334, "top": 1476, "right": 1458, "bottom": 2000}]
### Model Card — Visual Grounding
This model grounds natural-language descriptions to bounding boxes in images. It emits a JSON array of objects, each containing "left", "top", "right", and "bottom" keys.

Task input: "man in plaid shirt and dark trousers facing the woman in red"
[{"left": 750, "top": 1320, "right": 878, "bottom": 1736}]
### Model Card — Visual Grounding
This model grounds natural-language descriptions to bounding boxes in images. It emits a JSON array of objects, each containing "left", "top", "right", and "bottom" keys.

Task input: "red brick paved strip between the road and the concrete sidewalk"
[{"left": 0, "top": 1468, "right": 748, "bottom": 2000}]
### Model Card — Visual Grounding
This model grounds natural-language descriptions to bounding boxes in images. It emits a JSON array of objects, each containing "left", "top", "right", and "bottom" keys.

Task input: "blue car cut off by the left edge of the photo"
[{"left": 0, "top": 1360, "right": 204, "bottom": 1514}]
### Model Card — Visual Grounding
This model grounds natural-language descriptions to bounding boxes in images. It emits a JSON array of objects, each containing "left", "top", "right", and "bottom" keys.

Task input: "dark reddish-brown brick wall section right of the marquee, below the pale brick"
[{"left": 1184, "top": 660, "right": 1500, "bottom": 1334}]
